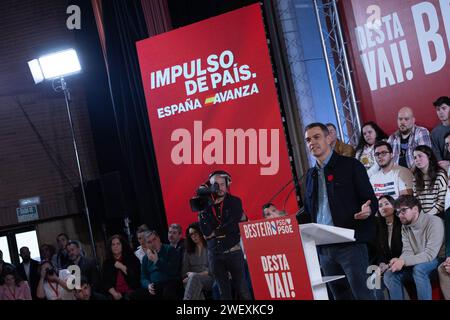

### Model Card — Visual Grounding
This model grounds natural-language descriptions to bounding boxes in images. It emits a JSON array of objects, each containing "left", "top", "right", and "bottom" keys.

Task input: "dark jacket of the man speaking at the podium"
[{"left": 304, "top": 152, "right": 378, "bottom": 243}]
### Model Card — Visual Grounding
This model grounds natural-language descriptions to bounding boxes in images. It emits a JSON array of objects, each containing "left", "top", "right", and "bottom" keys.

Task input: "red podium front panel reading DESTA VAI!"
[{"left": 240, "top": 216, "right": 313, "bottom": 300}]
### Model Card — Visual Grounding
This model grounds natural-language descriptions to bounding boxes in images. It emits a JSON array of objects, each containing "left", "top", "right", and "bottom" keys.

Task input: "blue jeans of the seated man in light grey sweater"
[{"left": 384, "top": 258, "right": 439, "bottom": 300}]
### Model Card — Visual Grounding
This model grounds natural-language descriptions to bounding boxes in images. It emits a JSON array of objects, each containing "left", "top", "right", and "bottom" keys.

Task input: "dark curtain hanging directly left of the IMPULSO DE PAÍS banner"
[{"left": 103, "top": 0, "right": 167, "bottom": 234}]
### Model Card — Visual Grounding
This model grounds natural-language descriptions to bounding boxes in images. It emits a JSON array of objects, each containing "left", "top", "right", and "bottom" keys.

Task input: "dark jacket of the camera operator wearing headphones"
[{"left": 199, "top": 193, "right": 243, "bottom": 253}]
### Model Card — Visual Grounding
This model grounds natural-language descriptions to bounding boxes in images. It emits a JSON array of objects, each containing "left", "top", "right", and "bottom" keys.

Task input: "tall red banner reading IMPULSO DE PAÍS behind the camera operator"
[{"left": 137, "top": 5, "right": 297, "bottom": 231}]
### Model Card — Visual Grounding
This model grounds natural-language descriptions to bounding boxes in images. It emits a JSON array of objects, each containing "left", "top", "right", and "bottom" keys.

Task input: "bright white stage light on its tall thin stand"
[{"left": 28, "top": 49, "right": 97, "bottom": 260}]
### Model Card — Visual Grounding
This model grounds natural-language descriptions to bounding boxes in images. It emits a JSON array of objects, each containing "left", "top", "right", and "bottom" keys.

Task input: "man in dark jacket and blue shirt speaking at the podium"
[{"left": 304, "top": 123, "right": 378, "bottom": 300}]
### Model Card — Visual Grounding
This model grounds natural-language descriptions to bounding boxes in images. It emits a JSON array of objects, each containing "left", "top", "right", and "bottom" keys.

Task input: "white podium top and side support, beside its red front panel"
[{"left": 299, "top": 223, "right": 355, "bottom": 300}]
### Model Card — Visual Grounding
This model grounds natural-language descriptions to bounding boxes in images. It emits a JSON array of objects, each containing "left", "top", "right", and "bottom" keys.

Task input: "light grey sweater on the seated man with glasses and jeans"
[{"left": 400, "top": 212, "right": 444, "bottom": 267}]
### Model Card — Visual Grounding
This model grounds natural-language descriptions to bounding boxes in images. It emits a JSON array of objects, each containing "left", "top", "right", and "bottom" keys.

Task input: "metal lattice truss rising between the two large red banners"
[{"left": 313, "top": 0, "right": 361, "bottom": 146}]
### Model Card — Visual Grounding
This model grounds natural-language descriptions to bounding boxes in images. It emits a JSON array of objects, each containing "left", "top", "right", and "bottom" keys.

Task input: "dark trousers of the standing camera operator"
[{"left": 208, "top": 250, "right": 251, "bottom": 300}]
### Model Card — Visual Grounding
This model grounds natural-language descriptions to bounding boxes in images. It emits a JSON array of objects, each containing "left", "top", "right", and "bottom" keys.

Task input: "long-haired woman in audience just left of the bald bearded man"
[{"left": 355, "top": 121, "right": 388, "bottom": 177}]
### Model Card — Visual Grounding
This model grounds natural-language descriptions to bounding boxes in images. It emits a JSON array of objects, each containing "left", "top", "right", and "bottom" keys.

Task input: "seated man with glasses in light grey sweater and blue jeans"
[{"left": 384, "top": 195, "right": 444, "bottom": 300}]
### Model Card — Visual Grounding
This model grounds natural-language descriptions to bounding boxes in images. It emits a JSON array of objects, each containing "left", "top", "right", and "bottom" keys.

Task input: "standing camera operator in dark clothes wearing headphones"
[{"left": 197, "top": 171, "right": 251, "bottom": 300}]
